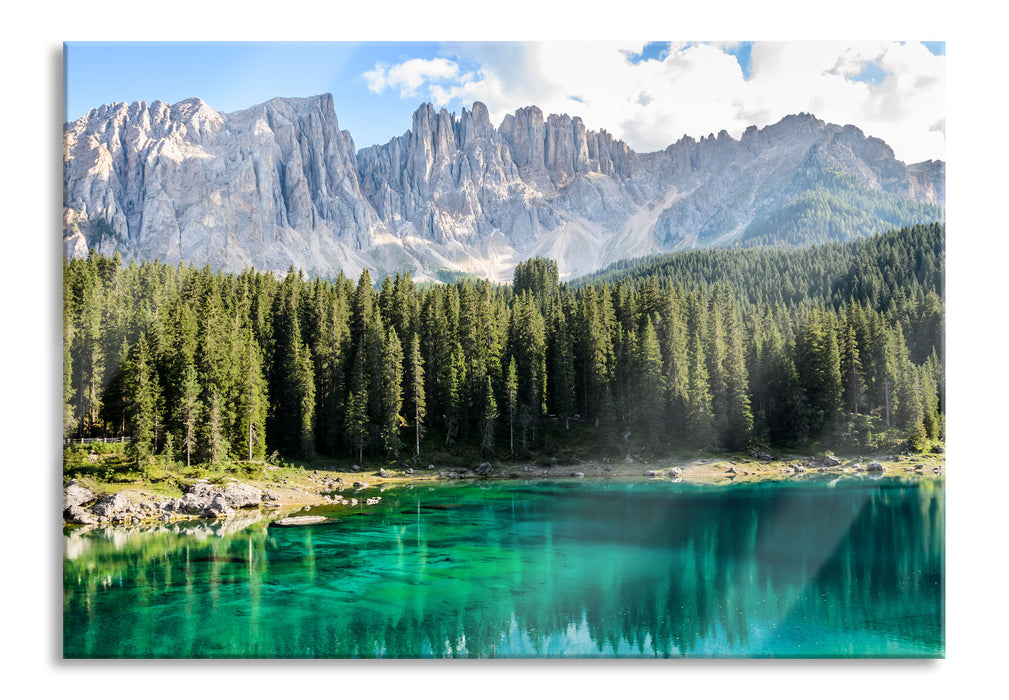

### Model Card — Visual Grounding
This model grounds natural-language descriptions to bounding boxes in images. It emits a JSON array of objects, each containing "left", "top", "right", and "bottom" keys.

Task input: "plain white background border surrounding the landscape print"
[{"left": 0, "top": 0, "right": 1009, "bottom": 700}]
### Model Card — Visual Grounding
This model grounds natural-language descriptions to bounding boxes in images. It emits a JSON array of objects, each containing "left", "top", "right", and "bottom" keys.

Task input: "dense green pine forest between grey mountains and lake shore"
[{"left": 63, "top": 224, "right": 945, "bottom": 465}]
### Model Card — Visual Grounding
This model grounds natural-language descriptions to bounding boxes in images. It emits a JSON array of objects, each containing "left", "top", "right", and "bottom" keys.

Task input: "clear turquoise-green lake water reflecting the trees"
[{"left": 64, "top": 478, "right": 944, "bottom": 658}]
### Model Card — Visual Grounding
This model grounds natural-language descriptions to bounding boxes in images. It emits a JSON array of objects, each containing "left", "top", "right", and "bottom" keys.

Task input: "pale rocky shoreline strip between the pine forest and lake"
[{"left": 63, "top": 451, "right": 945, "bottom": 526}]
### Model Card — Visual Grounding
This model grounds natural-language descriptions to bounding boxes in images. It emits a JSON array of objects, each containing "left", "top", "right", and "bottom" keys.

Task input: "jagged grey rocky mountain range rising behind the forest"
[{"left": 63, "top": 95, "right": 945, "bottom": 281}]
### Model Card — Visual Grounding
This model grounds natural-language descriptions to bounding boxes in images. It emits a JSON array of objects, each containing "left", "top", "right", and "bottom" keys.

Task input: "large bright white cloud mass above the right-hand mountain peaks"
[{"left": 364, "top": 41, "right": 945, "bottom": 162}]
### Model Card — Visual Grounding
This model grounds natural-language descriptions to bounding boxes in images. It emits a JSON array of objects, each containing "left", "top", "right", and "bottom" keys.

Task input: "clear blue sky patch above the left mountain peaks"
[{"left": 64, "top": 42, "right": 437, "bottom": 147}]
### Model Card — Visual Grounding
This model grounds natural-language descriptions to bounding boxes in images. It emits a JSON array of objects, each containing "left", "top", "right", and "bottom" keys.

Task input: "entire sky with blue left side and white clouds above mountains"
[{"left": 65, "top": 40, "right": 945, "bottom": 162}]
